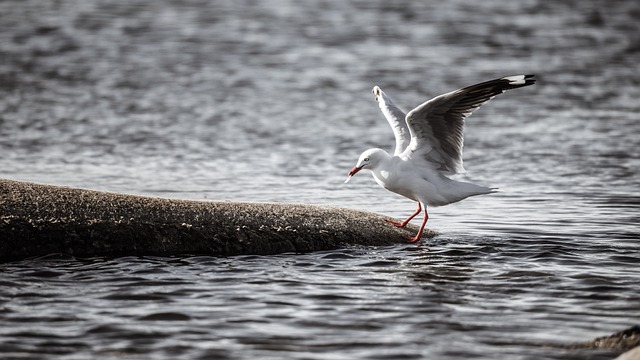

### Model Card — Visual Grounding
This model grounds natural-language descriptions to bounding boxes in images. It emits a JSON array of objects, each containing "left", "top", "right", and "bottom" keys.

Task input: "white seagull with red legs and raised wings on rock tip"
[{"left": 345, "top": 75, "right": 536, "bottom": 242}]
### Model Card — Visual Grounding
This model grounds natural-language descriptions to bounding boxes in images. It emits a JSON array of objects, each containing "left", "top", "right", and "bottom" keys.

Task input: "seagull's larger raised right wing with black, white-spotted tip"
[{"left": 402, "top": 75, "right": 535, "bottom": 174}]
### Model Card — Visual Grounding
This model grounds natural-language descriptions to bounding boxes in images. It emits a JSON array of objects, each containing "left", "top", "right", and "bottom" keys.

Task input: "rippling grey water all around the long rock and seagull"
[{"left": 0, "top": 0, "right": 640, "bottom": 359}]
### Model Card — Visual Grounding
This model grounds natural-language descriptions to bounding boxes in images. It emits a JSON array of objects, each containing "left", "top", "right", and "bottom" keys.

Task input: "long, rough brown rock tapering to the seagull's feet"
[{"left": 0, "top": 179, "right": 434, "bottom": 261}]
